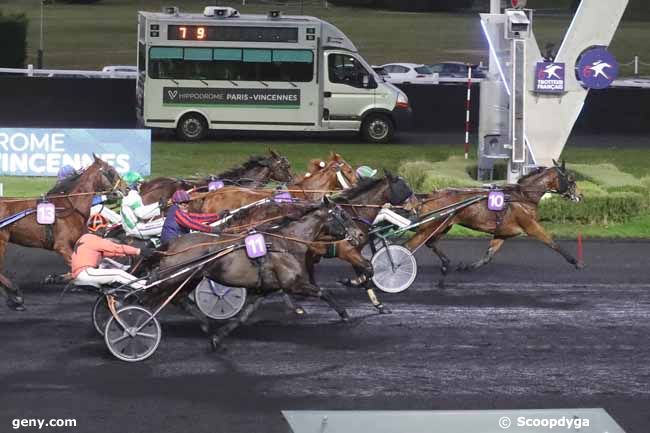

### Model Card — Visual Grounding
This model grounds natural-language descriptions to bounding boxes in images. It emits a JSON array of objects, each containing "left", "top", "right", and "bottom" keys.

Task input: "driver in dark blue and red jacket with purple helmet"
[{"left": 160, "top": 189, "right": 227, "bottom": 245}]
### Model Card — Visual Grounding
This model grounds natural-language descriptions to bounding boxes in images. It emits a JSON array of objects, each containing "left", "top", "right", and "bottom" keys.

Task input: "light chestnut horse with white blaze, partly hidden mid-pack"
[{"left": 197, "top": 154, "right": 358, "bottom": 213}]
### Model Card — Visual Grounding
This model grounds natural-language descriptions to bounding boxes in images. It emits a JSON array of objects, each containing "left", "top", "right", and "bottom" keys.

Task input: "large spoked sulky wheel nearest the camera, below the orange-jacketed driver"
[{"left": 104, "top": 305, "right": 162, "bottom": 362}]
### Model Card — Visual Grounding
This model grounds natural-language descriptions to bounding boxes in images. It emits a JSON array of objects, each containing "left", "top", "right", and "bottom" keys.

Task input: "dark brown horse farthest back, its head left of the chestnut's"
[{"left": 140, "top": 150, "right": 293, "bottom": 204}]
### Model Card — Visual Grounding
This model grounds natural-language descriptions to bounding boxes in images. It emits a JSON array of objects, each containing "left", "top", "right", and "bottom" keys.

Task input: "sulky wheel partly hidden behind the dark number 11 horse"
[{"left": 194, "top": 278, "right": 246, "bottom": 320}]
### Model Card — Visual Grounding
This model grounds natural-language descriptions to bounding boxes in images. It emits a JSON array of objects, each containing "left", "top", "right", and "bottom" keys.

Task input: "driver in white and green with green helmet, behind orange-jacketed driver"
[{"left": 120, "top": 171, "right": 165, "bottom": 240}]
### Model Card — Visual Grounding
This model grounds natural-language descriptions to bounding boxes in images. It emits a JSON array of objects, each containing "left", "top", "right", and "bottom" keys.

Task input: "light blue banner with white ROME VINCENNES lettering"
[{"left": 0, "top": 128, "right": 151, "bottom": 176}]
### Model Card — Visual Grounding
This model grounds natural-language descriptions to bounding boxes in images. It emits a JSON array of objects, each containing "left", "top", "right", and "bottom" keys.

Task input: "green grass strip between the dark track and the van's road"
[{"left": 0, "top": 139, "right": 650, "bottom": 238}]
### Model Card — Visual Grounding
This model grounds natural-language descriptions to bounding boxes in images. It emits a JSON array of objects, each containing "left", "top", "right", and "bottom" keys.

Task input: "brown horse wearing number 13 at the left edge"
[{"left": 0, "top": 155, "right": 125, "bottom": 310}]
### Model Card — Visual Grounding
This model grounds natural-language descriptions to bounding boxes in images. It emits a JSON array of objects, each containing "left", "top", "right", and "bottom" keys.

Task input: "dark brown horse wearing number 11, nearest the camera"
[{"left": 157, "top": 198, "right": 362, "bottom": 348}]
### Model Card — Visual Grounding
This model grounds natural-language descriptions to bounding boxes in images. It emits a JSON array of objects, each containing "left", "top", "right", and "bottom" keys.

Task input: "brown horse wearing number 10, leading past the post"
[{"left": 405, "top": 162, "right": 582, "bottom": 274}]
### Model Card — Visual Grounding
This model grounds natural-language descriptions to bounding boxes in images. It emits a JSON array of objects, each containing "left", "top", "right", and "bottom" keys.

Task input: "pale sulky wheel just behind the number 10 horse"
[{"left": 371, "top": 245, "right": 418, "bottom": 293}]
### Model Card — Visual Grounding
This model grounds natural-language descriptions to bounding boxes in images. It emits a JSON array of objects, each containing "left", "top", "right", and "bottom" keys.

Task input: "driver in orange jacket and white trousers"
[{"left": 70, "top": 218, "right": 154, "bottom": 289}]
